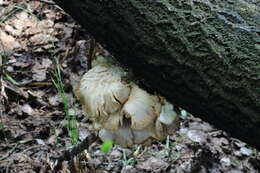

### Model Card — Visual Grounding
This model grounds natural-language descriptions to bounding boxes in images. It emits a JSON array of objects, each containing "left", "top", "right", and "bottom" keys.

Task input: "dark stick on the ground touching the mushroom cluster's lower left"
[{"left": 54, "top": 134, "right": 97, "bottom": 169}]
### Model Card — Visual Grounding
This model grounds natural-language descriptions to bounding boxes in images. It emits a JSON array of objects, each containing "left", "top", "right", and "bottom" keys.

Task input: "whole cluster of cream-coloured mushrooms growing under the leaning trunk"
[{"left": 76, "top": 56, "right": 179, "bottom": 147}]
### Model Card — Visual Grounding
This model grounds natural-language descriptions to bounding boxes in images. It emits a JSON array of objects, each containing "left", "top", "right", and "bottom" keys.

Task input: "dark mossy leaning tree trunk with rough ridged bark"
[{"left": 52, "top": 0, "right": 260, "bottom": 148}]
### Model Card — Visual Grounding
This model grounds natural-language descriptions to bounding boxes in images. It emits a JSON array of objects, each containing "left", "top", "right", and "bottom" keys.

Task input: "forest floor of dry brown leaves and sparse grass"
[{"left": 0, "top": 0, "right": 260, "bottom": 173}]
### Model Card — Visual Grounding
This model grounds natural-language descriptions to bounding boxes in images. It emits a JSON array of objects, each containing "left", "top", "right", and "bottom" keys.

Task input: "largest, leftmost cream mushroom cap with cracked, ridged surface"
[{"left": 76, "top": 61, "right": 130, "bottom": 129}]
